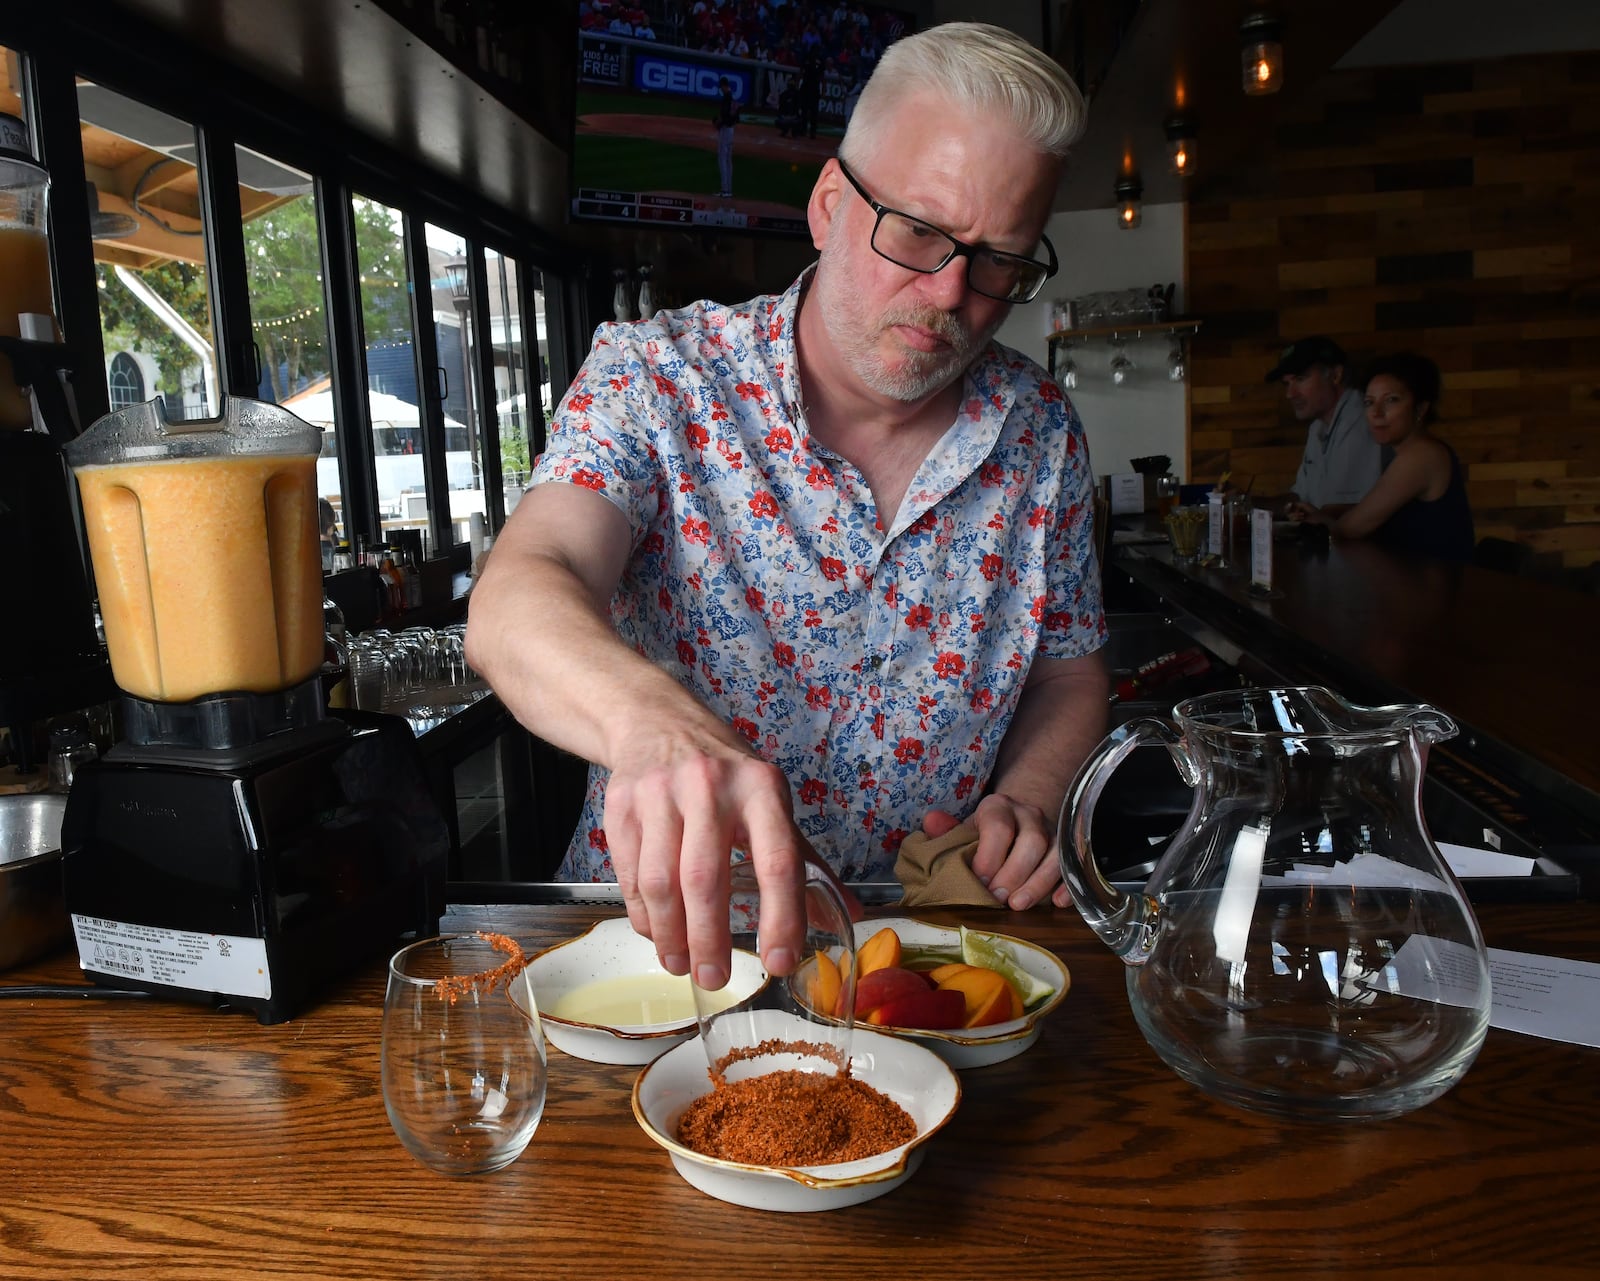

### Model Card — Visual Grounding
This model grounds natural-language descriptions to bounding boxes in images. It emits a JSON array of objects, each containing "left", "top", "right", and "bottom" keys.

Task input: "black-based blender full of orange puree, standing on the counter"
[{"left": 61, "top": 398, "right": 450, "bottom": 1024}]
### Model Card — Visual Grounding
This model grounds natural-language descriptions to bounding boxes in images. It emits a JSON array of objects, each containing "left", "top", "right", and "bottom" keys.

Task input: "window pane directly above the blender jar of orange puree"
[{"left": 78, "top": 80, "right": 219, "bottom": 419}]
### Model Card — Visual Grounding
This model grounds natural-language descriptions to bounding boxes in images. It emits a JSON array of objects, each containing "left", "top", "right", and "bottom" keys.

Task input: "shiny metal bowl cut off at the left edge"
[{"left": 0, "top": 792, "right": 70, "bottom": 969}]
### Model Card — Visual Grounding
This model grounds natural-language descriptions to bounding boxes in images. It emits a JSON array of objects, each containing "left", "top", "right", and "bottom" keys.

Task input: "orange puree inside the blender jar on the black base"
[{"left": 77, "top": 456, "right": 323, "bottom": 702}]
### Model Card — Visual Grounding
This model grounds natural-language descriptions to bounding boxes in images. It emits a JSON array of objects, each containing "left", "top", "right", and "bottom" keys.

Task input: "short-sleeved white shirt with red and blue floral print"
[{"left": 533, "top": 275, "right": 1106, "bottom": 881}]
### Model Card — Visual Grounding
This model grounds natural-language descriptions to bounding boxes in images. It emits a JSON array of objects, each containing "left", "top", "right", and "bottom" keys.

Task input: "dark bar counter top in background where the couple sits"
[{"left": 1110, "top": 531, "right": 1600, "bottom": 822}]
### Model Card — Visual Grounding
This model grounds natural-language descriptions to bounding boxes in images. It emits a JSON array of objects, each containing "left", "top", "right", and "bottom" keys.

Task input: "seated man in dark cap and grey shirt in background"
[{"left": 1267, "top": 334, "right": 1384, "bottom": 513}]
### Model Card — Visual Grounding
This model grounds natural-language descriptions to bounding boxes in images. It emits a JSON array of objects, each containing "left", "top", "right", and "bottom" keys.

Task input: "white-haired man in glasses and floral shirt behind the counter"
[{"left": 467, "top": 22, "right": 1107, "bottom": 988}]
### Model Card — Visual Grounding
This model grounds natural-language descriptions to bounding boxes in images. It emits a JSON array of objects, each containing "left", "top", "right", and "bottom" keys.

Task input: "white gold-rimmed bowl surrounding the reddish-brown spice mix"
[{"left": 634, "top": 1009, "right": 962, "bottom": 1212}]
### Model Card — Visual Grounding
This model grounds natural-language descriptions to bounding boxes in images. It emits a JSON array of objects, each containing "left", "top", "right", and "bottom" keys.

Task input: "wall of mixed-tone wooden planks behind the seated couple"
[{"left": 1187, "top": 53, "right": 1600, "bottom": 568}]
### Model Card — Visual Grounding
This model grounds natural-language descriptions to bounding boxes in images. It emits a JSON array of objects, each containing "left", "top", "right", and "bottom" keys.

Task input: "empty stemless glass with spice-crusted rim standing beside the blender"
[{"left": 382, "top": 934, "right": 546, "bottom": 1174}]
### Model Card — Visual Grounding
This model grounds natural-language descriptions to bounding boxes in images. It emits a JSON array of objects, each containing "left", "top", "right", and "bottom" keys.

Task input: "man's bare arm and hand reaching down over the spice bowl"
[{"left": 467, "top": 485, "right": 810, "bottom": 988}]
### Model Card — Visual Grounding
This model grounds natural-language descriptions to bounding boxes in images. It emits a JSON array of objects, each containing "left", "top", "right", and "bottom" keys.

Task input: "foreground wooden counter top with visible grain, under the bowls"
[{"left": 0, "top": 904, "right": 1600, "bottom": 1281}]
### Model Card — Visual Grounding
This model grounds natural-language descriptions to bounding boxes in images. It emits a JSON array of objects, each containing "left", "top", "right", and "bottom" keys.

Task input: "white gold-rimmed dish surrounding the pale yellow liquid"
[{"left": 528, "top": 916, "right": 766, "bottom": 1067}]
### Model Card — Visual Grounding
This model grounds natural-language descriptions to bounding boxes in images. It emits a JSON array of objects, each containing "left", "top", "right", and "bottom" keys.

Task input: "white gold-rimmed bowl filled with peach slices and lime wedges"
[{"left": 794, "top": 916, "right": 1072, "bottom": 1068}]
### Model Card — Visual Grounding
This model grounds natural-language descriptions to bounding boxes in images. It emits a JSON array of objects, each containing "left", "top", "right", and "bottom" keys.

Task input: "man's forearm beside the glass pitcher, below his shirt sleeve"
[{"left": 990, "top": 652, "right": 1110, "bottom": 830}]
